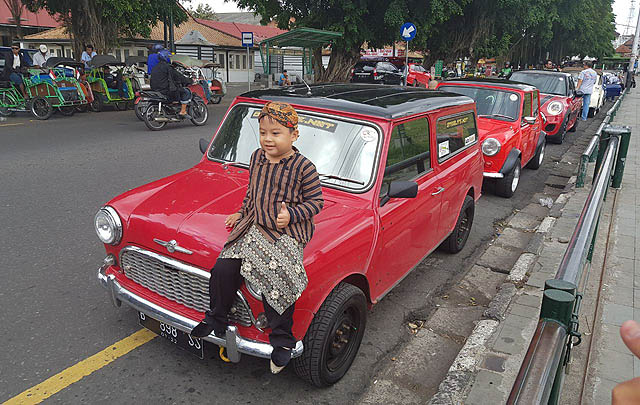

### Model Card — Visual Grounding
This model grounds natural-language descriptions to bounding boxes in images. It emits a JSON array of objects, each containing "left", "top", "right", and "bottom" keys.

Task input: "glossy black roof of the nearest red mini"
[{"left": 240, "top": 83, "right": 474, "bottom": 119}]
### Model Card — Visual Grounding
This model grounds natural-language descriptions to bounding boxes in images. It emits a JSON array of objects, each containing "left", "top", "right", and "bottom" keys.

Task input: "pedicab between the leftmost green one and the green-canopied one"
[{"left": 44, "top": 57, "right": 93, "bottom": 116}]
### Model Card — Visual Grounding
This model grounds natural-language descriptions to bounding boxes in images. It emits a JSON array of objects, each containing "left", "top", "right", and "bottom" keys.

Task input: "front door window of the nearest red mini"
[{"left": 380, "top": 118, "right": 431, "bottom": 196}]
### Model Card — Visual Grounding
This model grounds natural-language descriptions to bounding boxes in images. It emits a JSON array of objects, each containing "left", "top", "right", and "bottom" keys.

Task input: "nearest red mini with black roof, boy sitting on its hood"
[{"left": 95, "top": 84, "right": 482, "bottom": 386}]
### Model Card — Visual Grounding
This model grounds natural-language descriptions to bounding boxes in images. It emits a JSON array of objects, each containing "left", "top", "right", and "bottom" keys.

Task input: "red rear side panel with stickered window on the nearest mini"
[{"left": 434, "top": 109, "right": 480, "bottom": 240}]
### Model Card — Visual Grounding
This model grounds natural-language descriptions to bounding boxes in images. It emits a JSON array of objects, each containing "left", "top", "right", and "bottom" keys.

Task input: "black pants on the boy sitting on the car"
[{"left": 205, "top": 259, "right": 296, "bottom": 366}]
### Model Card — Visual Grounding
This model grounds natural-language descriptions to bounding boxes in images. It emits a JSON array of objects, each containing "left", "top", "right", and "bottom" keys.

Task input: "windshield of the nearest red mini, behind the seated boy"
[{"left": 208, "top": 105, "right": 380, "bottom": 191}]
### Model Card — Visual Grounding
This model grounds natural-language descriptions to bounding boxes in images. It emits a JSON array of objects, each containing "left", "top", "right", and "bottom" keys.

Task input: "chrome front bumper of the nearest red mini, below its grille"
[{"left": 98, "top": 265, "right": 303, "bottom": 363}]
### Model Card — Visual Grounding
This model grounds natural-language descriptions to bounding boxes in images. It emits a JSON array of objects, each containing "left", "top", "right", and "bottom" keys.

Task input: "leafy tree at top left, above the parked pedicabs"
[{"left": 23, "top": 0, "right": 187, "bottom": 54}]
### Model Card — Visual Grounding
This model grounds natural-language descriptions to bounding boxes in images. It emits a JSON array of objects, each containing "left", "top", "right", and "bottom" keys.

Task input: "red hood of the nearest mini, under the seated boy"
[{"left": 109, "top": 165, "right": 373, "bottom": 269}]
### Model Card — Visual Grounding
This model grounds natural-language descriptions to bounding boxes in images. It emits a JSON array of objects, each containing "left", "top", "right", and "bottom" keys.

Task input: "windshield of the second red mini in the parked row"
[{"left": 438, "top": 86, "right": 520, "bottom": 121}]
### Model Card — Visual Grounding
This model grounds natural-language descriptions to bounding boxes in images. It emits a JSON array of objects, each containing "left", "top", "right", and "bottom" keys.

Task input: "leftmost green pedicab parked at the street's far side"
[{"left": 0, "top": 63, "right": 86, "bottom": 120}]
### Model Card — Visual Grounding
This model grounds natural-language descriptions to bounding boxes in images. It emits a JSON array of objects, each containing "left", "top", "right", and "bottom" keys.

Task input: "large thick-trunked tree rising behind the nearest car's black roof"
[{"left": 237, "top": 0, "right": 470, "bottom": 81}]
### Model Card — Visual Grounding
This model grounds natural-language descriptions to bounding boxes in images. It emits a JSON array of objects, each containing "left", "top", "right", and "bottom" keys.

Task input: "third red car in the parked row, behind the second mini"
[{"left": 509, "top": 70, "right": 582, "bottom": 143}]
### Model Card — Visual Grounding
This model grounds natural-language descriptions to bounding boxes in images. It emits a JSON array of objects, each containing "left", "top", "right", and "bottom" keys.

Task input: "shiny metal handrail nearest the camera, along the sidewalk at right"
[{"left": 507, "top": 137, "right": 619, "bottom": 405}]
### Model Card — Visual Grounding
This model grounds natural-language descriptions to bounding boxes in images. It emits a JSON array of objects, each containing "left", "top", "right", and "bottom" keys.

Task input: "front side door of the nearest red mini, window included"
[{"left": 371, "top": 116, "right": 442, "bottom": 295}]
